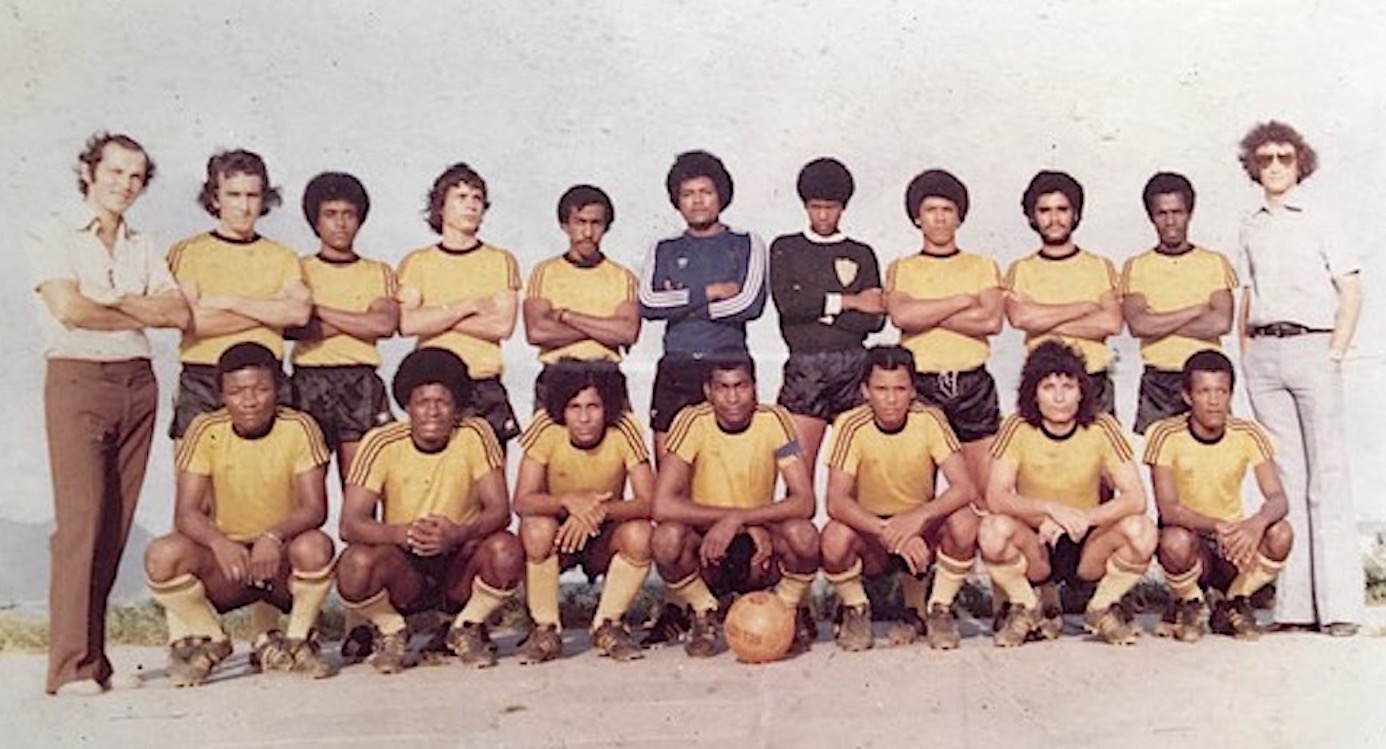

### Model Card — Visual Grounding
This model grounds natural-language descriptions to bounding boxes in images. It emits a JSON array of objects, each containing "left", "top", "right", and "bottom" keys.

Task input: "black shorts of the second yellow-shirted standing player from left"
[{"left": 294, "top": 365, "right": 395, "bottom": 451}]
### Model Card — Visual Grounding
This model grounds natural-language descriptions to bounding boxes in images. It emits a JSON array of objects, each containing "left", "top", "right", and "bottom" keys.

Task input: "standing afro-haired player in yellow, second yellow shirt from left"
[{"left": 286, "top": 172, "right": 399, "bottom": 485}]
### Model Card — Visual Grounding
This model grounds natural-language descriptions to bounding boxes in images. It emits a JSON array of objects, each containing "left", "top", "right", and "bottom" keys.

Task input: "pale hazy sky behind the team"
[{"left": 0, "top": 0, "right": 1386, "bottom": 603}]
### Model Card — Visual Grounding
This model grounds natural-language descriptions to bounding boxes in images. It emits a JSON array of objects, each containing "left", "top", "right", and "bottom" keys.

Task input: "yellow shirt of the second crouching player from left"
[{"left": 347, "top": 417, "right": 505, "bottom": 526}]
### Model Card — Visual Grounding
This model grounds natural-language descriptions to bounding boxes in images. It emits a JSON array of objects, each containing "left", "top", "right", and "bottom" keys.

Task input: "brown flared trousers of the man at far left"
[{"left": 43, "top": 359, "right": 158, "bottom": 694}]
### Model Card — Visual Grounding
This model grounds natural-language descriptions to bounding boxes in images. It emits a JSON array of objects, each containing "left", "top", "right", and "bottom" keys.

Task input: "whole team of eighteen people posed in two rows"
[{"left": 30, "top": 121, "right": 1364, "bottom": 695}]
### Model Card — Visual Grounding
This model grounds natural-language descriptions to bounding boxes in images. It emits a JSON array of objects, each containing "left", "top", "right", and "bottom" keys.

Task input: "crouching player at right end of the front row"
[{"left": 1145, "top": 350, "right": 1295, "bottom": 641}]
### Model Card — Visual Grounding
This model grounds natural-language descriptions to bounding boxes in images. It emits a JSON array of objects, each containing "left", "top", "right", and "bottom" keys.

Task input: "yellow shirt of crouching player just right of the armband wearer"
[{"left": 827, "top": 402, "right": 960, "bottom": 516}]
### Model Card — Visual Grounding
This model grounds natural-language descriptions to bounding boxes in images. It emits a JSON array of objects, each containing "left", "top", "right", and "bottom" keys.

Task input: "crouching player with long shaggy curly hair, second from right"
[{"left": 977, "top": 341, "right": 1159, "bottom": 646}]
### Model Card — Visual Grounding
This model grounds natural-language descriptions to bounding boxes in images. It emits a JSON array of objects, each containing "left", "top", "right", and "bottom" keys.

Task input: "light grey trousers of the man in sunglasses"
[{"left": 1242, "top": 333, "right": 1365, "bottom": 624}]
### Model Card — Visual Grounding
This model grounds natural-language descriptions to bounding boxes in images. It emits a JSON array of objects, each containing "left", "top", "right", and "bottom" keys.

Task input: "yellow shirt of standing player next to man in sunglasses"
[{"left": 1121, "top": 247, "right": 1238, "bottom": 372}]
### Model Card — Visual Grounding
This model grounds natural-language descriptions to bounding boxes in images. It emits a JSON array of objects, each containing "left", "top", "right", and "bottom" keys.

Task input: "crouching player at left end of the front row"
[{"left": 144, "top": 343, "right": 334, "bottom": 687}]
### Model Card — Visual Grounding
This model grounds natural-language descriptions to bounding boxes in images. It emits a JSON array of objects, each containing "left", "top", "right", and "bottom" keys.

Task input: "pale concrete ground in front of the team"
[{"left": 0, "top": 617, "right": 1386, "bottom": 749}]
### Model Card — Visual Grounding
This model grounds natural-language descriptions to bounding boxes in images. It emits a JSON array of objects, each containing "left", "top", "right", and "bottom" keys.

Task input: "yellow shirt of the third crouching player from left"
[{"left": 520, "top": 409, "right": 650, "bottom": 501}]
